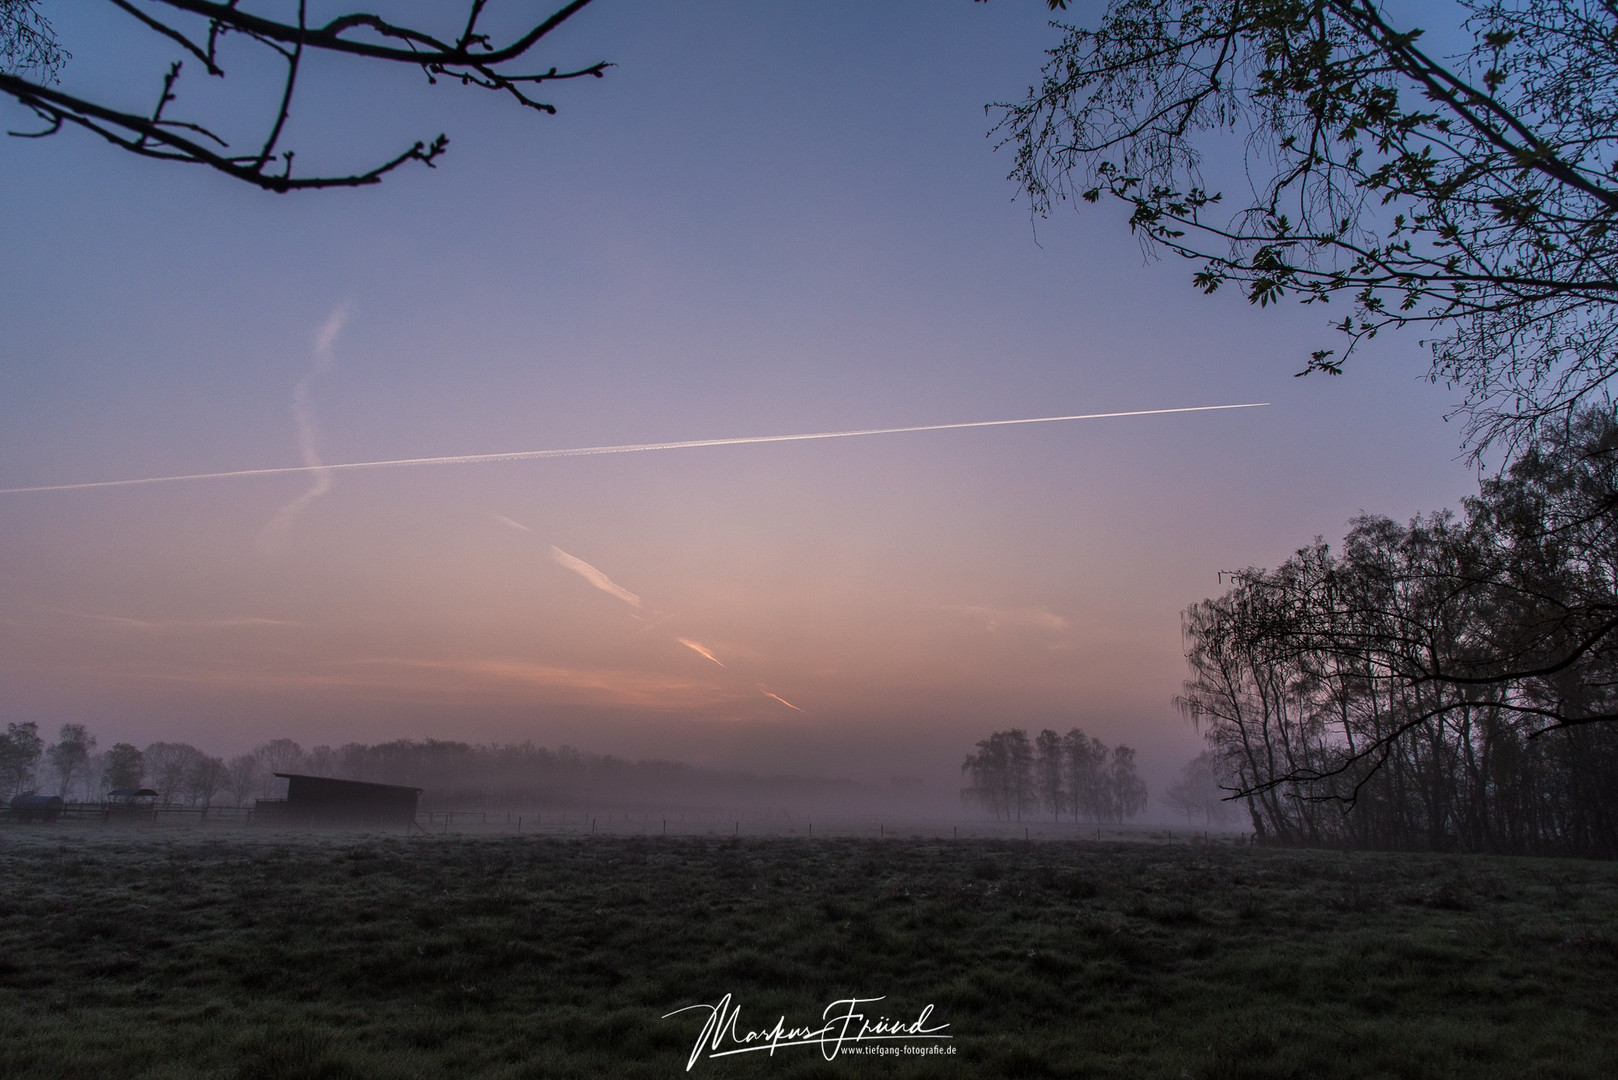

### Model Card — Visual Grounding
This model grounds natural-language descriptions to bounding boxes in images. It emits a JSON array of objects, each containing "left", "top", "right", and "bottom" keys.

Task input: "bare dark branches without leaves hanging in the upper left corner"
[{"left": 0, "top": 0, "right": 610, "bottom": 191}]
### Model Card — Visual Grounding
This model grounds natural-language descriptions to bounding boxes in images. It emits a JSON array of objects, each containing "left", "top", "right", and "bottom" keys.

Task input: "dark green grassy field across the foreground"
[{"left": 0, "top": 826, "right": 1618, "bottom": 1080}]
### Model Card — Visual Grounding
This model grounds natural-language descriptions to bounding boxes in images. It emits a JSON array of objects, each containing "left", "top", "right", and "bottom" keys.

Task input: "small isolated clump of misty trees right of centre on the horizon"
[{"left": 961, "top": 727, "right": 1147, "bottom": 824}]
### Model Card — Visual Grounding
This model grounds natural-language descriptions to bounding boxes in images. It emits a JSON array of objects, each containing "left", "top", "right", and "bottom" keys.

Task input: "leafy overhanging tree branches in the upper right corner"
[{"left": 997, "top": 0, "right": 1618, "bottom": 457}]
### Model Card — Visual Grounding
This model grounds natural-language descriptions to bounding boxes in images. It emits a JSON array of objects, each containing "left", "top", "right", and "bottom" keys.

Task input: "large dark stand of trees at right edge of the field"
[{"left": 1180, "top": 410, "right": 1618, "bottom": 857}]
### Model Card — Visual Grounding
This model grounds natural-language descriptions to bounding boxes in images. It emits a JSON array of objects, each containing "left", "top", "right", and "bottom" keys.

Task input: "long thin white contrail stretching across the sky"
[{"left": 0, "top": 402, "right": 1269, "bottom": 495}]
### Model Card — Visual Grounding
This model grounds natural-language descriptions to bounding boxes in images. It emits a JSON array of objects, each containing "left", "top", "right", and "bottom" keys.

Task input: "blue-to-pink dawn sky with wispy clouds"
[{"left": 0, "top": 0, "right": 1476, "bottom": 790}]
